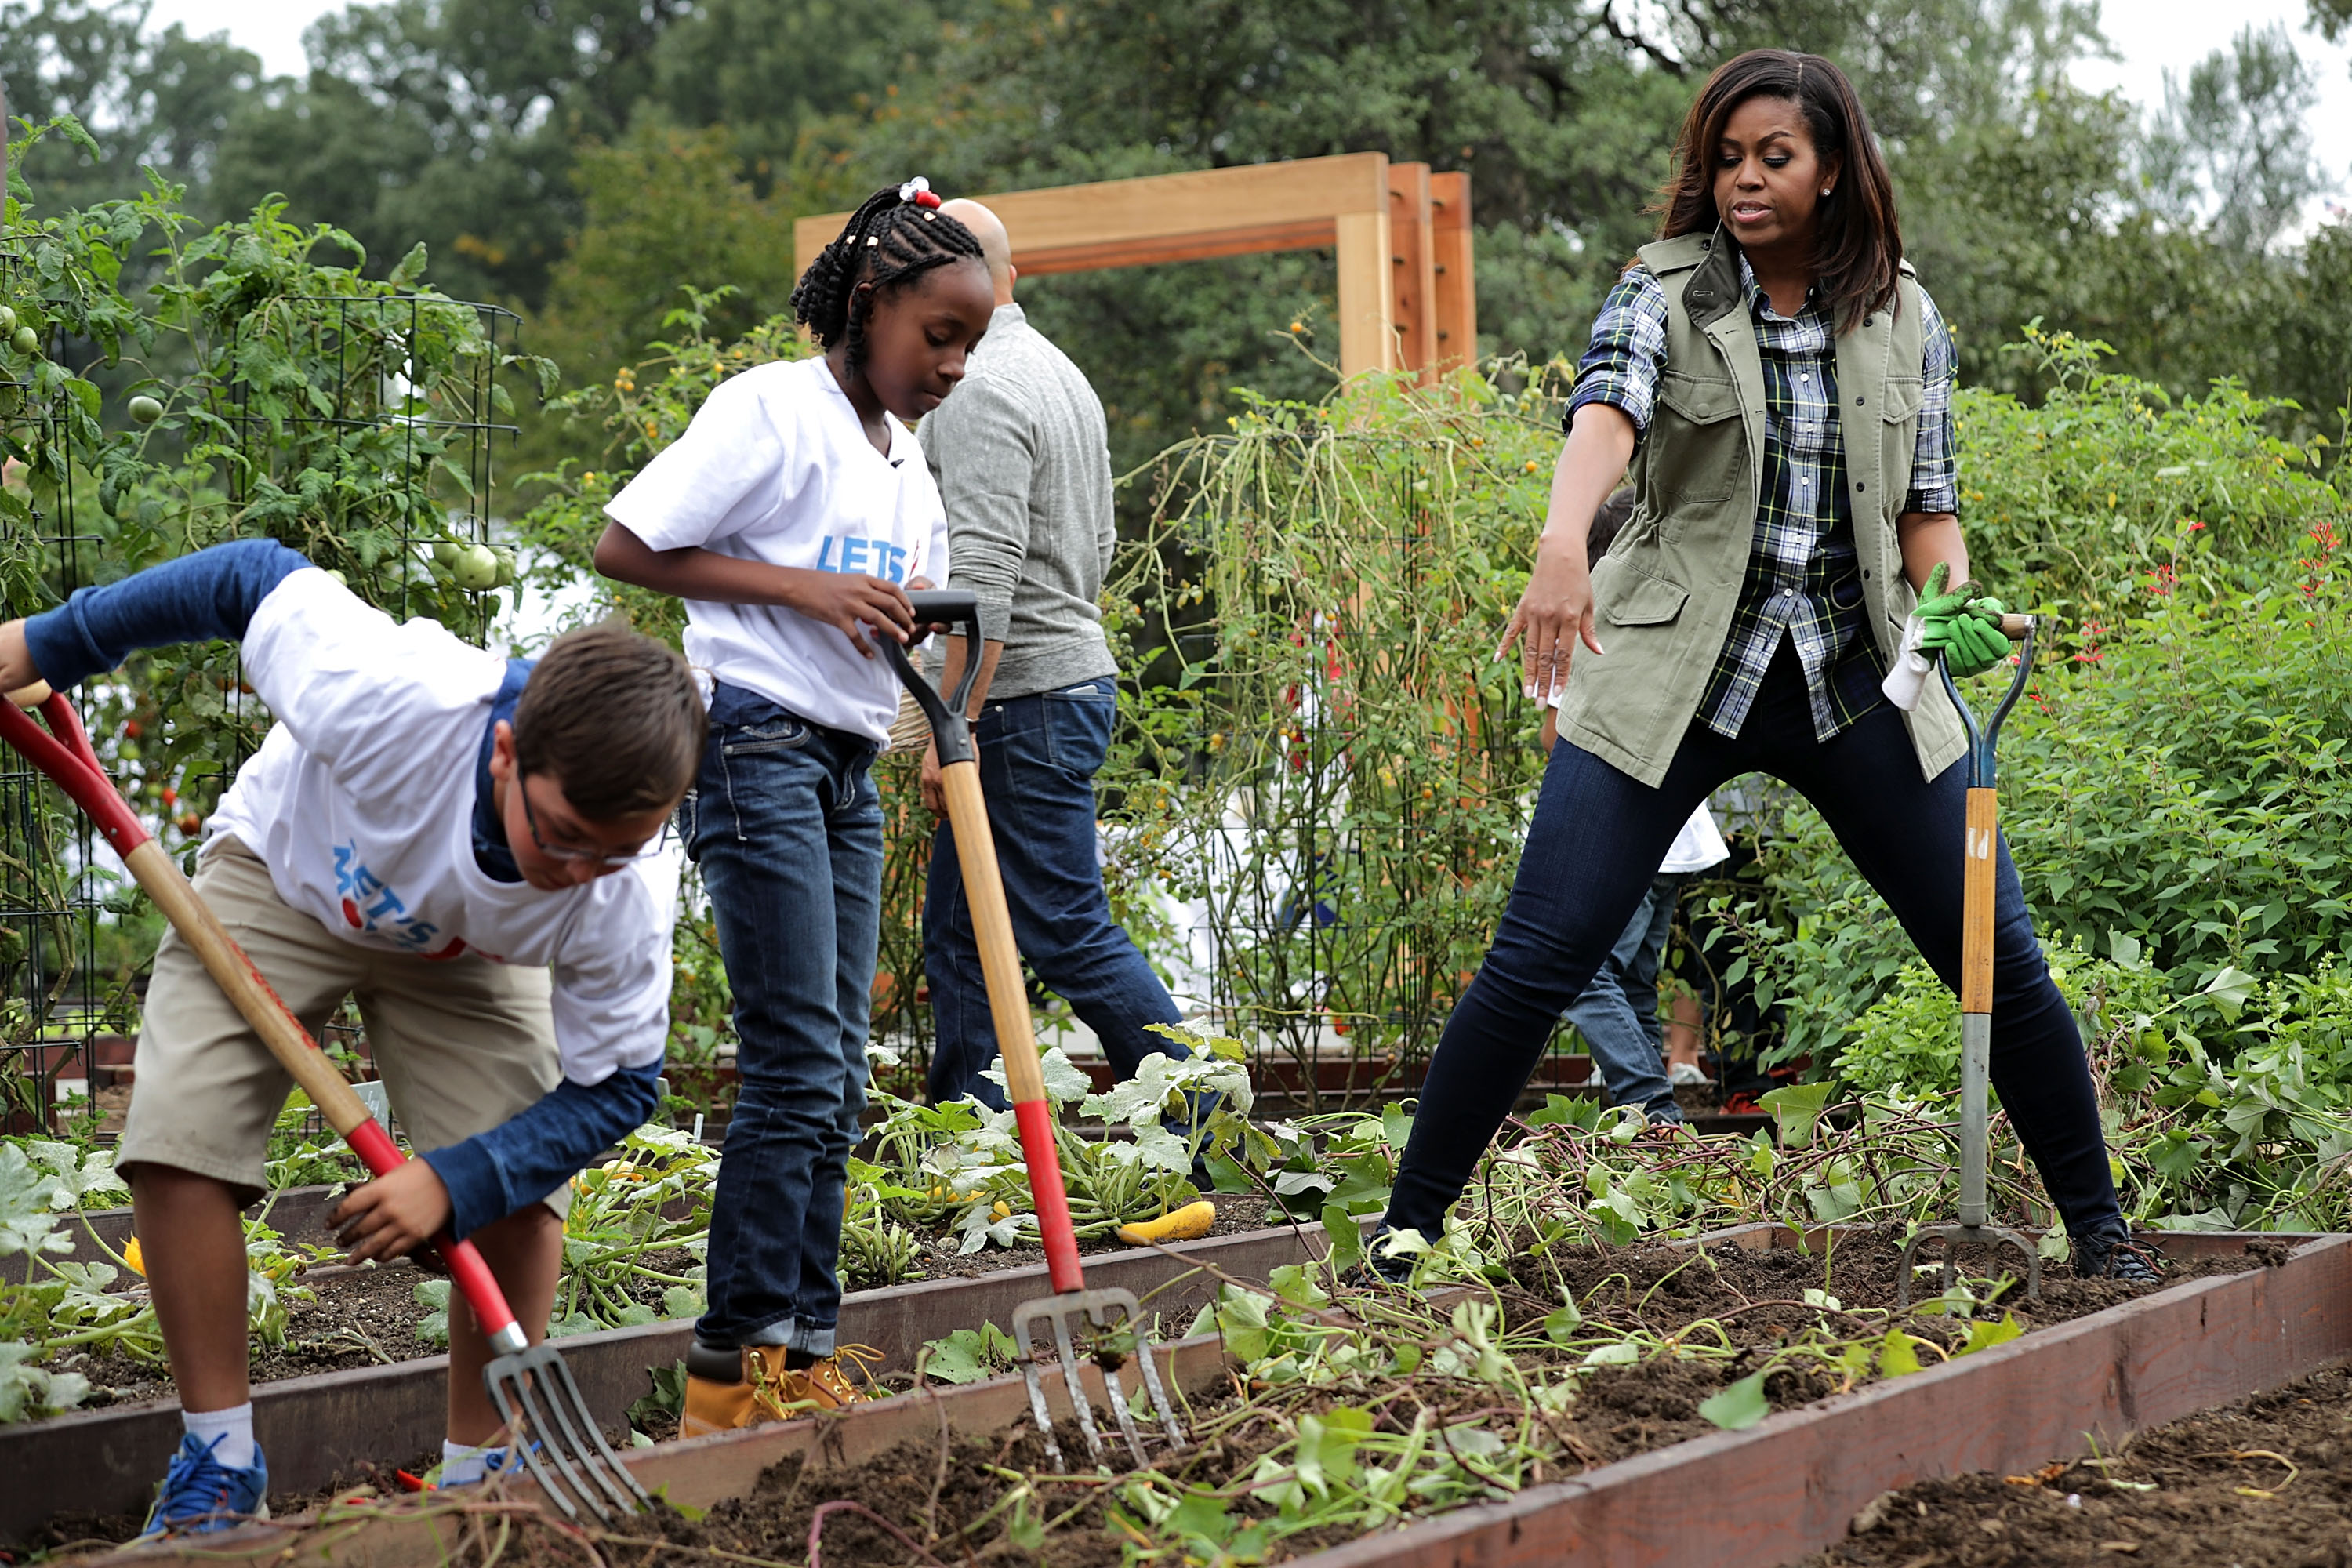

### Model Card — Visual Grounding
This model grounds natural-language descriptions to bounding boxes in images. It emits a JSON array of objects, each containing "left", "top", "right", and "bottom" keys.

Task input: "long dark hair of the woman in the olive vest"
[{"left": 1658, "top": 49, "right": 1903, "bottom": 332}]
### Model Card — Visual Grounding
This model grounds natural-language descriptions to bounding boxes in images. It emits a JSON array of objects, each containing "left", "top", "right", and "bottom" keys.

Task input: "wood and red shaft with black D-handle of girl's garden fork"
[{"left": 882, "top": 588, "right": 1087, "bottom": 1293}]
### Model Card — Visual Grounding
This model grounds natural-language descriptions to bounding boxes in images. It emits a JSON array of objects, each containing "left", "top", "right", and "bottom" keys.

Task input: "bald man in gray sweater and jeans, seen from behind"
[{"left": 922, "top": 202, "right": 1185, "bottom": 1109}]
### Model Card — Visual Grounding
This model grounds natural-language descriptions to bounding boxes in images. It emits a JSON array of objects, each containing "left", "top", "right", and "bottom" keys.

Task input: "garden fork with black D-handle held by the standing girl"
[{"left": 880, "top": 590, "right": 1183, "bottom": 1465}]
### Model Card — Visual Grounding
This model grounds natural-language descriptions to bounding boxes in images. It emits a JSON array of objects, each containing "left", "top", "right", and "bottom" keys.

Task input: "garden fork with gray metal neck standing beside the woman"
[{"left": 1896, "top": 616, "right": 2042, "bottom": 1307}]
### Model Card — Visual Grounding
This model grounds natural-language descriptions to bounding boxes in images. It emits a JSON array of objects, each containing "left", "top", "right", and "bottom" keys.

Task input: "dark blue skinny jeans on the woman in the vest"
[{"left": 1388, "top": 642, "right": 2119, "bottom": 1239}]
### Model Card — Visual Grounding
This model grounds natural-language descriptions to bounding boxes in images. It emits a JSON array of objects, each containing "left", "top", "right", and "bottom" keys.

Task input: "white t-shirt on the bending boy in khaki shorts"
[{"left": 207, "top": 567, "right": 680, "bottom": 1086}]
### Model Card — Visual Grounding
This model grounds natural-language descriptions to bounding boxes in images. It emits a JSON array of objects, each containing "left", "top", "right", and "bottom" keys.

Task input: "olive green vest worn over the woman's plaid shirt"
[{"left": 1559, "top": 235, "right": 1966, "bottom": 787}]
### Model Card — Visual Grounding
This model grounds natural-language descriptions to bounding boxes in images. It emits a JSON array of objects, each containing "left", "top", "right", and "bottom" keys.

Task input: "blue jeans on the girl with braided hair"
[{"left": 682, "top": 687, "right": 882, "bottom": 1356}]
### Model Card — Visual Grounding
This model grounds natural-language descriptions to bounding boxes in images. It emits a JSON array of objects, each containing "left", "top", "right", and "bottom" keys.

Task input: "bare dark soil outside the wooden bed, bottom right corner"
[{"left": 1806, "top": 1366, "right": 2352, "bottom": 1568}]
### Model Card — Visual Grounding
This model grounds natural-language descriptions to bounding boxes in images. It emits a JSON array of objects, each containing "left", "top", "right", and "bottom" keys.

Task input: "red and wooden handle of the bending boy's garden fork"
[{"left": 0, "top": 687, "right": 527, "bottom": 1354}]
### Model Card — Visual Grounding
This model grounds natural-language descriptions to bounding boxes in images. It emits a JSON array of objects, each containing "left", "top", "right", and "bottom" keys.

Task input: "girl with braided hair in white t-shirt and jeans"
[{"left": 595, "top": 179, "right": 995, "bottom": 1436}]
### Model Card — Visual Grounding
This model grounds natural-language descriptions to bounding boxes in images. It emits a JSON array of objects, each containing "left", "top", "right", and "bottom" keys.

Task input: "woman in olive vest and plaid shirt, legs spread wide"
[{"left": 1376, "top": 49, "right": 2154, "bottom": 1279}]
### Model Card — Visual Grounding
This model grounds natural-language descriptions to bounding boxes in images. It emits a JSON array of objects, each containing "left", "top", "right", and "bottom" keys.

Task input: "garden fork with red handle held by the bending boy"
[{"left": 0, "top": 684, "right": 649, "bottom": 1519}]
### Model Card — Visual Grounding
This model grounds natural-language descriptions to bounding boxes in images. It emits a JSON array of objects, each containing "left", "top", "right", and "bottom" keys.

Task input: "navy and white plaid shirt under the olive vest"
[{"left": 1569, "top": 256, "right": 1959, "bottom": 741}]
